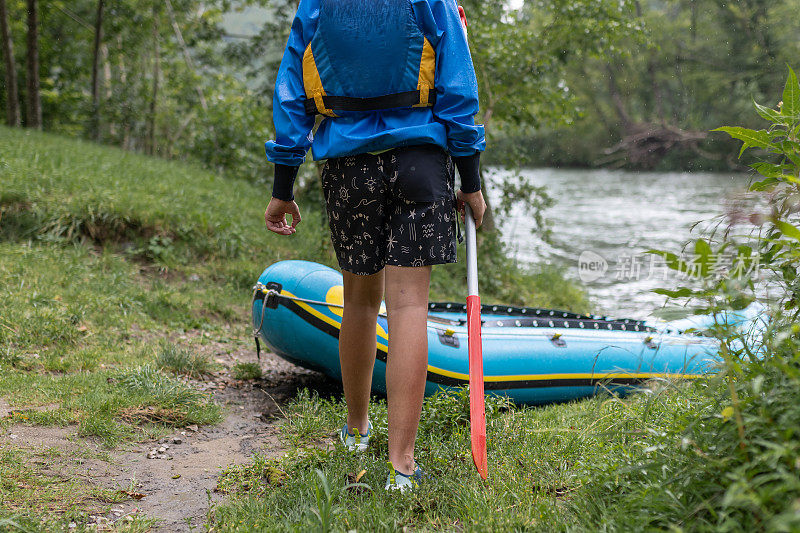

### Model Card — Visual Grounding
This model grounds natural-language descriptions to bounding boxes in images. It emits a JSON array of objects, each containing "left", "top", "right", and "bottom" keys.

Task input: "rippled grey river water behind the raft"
[{"left": 492, "top": 168, "right": 749, "bottom": 318}]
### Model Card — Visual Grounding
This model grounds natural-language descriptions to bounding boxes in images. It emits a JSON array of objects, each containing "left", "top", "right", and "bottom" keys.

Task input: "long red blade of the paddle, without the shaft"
[{"left": 467, "top": 295, "right": 489, "bottom": 479}]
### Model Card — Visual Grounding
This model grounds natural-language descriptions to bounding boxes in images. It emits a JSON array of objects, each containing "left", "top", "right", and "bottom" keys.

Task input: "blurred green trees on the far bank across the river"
[{"left": 500, "top": 0, "right": 800, "bottom": 170}]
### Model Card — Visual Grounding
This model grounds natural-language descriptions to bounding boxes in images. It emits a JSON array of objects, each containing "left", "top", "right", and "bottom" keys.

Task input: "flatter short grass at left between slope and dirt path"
[{"left": 0, "top": 243, "right": 222, "bottom": 445}]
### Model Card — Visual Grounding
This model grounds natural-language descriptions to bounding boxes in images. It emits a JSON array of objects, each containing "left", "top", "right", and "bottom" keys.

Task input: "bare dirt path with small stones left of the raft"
[{"left": 0, "top": 343, "right": 330, "bottom": 532}]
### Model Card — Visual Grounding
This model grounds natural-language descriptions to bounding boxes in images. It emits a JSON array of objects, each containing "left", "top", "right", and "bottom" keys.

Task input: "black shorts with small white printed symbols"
[{"left": 322, "top": 145, "right": 457, "bottom": 275}]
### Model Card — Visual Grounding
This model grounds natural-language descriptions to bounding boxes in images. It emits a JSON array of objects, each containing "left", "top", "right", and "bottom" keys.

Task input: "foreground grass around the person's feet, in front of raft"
[{"left": 209, "top": 389, "right": 687, "bottom": 531}]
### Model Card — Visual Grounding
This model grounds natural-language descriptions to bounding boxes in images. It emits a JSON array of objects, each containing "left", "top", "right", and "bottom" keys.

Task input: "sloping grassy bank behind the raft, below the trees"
[{"left": 0, "top": 127, "right": 588, "bottom": 311}]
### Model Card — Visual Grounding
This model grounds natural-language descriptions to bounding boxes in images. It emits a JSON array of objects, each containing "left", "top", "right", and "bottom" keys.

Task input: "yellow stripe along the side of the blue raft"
[{"left": 281, "top": 290, "right": 703, "bottom": 382}]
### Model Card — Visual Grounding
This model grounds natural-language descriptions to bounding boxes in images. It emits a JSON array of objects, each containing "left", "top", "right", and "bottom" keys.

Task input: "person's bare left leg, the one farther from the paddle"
[{"left": 339, "top": 270, "right": 384, "bottom": 433}]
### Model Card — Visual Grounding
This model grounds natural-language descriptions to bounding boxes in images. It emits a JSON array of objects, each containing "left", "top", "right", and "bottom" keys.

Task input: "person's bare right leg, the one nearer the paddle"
[{"left": 385, "top": 266, "right": 431, "bottom": 474}]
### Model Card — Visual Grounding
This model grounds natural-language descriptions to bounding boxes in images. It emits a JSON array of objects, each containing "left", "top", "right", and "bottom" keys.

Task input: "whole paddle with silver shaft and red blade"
[{"left": 464, "top": 205, "right": 489, "bottom": 479}]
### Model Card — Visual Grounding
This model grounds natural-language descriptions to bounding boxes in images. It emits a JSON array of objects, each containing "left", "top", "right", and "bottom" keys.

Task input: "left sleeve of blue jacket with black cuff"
[{"left": 264, "top": 0, "right": 319, "bottom": 200}]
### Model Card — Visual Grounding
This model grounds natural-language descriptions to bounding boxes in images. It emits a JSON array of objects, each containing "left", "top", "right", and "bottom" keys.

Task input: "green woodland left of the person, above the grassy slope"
[{"left": 0, "top": 0, "right": 269, "bottom": 182}]
